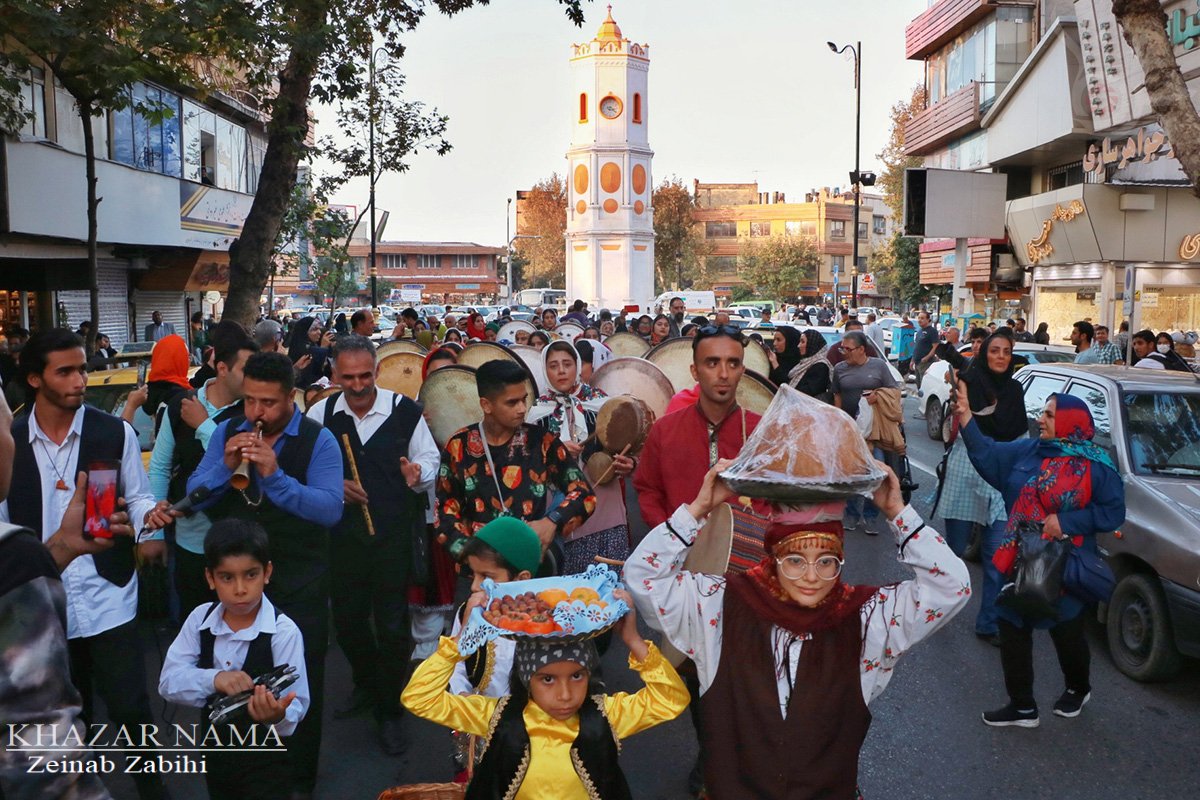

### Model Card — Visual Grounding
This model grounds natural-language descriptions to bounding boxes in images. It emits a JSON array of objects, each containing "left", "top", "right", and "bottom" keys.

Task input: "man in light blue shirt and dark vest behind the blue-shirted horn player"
[{"left": 150, "top": 320, "right": 258, "bottom": 619}]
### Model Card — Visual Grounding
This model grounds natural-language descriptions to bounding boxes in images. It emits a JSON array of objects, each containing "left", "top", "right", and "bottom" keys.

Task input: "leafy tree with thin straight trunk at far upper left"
[{"left": 0, "top": 0, "right": 222, "bottom": 353}]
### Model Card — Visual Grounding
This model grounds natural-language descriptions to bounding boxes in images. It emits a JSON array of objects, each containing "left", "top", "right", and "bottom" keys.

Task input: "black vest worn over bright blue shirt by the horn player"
[{"left": 205, "top": 415, "right": 329, "bottom": 604}]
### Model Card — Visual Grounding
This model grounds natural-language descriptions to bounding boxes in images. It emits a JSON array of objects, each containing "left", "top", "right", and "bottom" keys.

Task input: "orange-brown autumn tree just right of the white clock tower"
[{"left": 652, "top": 175, "right": 713, "bottom": 291}]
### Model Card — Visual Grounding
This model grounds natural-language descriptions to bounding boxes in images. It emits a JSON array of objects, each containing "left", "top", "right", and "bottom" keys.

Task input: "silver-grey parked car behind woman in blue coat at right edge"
[{"left": 1016, "top": 363, "right": 1200, "bottom": 681}]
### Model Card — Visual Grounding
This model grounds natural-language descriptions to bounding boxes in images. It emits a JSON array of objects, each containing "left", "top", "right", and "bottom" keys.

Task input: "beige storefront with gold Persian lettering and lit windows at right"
[{"left": 1007, "top": 184, "right": 1200, "bottom": 343}]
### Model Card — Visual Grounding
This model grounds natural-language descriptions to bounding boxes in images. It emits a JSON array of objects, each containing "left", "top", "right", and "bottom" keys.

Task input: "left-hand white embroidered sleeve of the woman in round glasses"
[{"left": 625, "top": 506, "right": 725, "bottom": 692}]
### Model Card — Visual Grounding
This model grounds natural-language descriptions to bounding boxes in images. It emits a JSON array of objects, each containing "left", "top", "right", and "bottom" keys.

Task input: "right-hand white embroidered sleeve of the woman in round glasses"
[{"left": 859, "top": 506, "right": 971, "bottom": 703}]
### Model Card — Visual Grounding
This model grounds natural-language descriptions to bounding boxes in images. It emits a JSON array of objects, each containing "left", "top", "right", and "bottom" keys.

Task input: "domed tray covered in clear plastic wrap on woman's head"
[{"left": 721, "top": 385, "right": 886, "bottom": 504}]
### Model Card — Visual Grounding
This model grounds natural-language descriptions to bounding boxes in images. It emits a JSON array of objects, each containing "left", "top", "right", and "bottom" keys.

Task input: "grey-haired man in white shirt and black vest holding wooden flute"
[{"left": 308, "top": 336, "right": 440, "bottom": 756}]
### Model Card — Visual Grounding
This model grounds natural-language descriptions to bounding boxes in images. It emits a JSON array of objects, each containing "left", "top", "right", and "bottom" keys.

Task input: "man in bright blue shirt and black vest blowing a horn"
[{"left": 187, "top": 353, "right": 342, "bottom": 798}]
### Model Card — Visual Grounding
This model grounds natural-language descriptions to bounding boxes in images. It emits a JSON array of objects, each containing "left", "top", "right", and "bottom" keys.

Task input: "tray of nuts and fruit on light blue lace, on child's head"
[{"left": 458, "top": 564, "right": 629, "bottom": 654}]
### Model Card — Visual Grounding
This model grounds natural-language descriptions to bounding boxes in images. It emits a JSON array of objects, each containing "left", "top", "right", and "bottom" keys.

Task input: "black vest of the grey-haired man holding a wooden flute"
[{"left": 325, "top": 392, "right": 424, "bottom": 553}]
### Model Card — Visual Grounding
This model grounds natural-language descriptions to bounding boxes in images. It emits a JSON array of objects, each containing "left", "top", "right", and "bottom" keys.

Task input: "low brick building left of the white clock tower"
[{"left": 348, "top": 241, "right": 505, "bottom": 305}]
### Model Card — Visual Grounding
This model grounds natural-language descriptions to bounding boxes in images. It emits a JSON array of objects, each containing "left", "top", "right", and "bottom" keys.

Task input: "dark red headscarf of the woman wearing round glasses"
[{"left": 727, "top": 522, "right": 878, "bottom": 636}]
